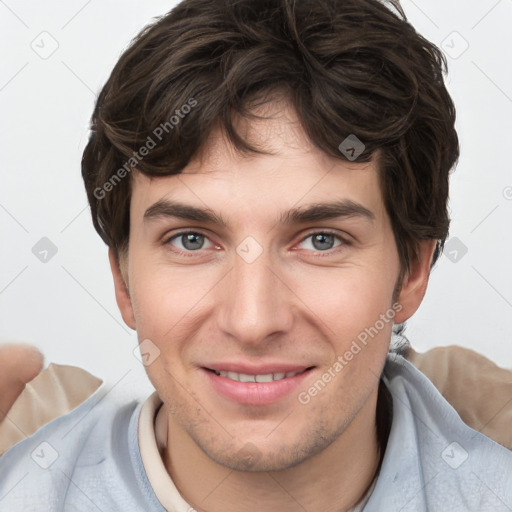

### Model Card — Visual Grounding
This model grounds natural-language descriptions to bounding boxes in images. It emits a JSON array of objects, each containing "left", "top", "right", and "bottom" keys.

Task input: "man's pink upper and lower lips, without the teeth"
[{"left": 201, "top": 364, "right": 313, "bottom": 406}]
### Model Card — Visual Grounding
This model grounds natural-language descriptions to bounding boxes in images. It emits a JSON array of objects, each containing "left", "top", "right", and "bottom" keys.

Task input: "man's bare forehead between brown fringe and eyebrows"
[{"left": 132, "top": 101, "right": 383, "bottom": 226}]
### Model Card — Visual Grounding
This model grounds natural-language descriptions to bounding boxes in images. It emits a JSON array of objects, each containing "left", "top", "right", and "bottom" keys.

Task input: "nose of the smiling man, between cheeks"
[{"left": 217, "top": 245, "right": 293, "bottom": 346}]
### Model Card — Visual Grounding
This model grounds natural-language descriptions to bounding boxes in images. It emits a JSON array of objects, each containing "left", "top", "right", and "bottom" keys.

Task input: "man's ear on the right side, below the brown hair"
[{"left": 395, "top": 240, "right": 437, "bottom": 323}]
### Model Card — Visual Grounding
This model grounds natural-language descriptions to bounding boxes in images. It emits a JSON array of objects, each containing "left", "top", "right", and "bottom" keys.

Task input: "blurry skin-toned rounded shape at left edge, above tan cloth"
[{"left": 0, "top": 344, "right": 44, "bottom": 421}]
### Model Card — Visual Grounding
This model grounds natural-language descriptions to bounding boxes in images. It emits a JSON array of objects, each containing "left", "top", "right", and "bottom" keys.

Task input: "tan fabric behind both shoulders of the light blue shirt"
[{"left": 0, "top": 346, "right": 512, "bottom": 455}]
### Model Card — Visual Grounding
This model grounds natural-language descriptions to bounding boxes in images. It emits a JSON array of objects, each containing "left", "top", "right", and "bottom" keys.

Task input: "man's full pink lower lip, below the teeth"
[{"left": 203, "top": 368, "right": 311, "bottom": 405}]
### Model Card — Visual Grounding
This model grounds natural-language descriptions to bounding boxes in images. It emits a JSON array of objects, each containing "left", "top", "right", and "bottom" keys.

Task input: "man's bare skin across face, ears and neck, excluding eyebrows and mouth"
[{"left": 110, "top": 100, "right": 435, "bottom": 512}]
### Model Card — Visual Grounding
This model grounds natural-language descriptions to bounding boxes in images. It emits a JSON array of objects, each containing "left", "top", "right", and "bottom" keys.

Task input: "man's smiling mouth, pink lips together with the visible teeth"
[{"left": 202, "top": 365, "right": 315, "bottom": 406}]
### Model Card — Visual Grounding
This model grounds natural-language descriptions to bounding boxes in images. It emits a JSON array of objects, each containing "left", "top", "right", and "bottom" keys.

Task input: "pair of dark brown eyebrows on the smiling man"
[{"left": 144, "top": 199, "right": 375, "bottom": 228}]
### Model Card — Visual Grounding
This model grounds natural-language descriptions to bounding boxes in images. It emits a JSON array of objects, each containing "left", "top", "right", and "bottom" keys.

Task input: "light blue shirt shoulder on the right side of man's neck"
[{"left": 365, "top": 355, "right": 512, "bottom": 512}]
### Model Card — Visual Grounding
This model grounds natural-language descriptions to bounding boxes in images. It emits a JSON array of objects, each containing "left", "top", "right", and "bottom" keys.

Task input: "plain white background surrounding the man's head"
[{"left": 0, "top": 0, "right": 512, "bottom": 395}]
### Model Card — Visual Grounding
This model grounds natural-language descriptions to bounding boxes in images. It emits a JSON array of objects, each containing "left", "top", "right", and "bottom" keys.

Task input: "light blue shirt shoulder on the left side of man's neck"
[{"left": 0, "top": 366, "right": 150, "bottom": 512}]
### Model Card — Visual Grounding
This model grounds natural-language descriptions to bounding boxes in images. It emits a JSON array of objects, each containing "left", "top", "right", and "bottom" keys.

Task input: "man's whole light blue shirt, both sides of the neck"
[{"left": 0, "top": 354, "right": 512, "bottom": 512}]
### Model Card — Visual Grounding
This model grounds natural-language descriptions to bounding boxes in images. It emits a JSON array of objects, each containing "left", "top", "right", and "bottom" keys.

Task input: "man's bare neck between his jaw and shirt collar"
[{"left": 164, "top": 381, "right": 390, "bottom": 512}]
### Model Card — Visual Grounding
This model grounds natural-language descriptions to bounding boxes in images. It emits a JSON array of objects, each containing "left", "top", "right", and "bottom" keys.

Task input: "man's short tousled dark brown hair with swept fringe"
[{"left": 82, "top": 0, "right": 459, "bottom": 270}]
